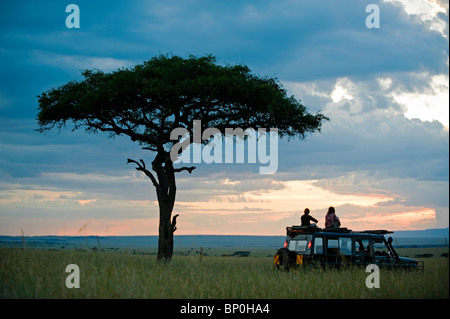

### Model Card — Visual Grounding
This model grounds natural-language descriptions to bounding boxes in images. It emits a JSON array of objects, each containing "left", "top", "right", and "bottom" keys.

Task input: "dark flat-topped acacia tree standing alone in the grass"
[{"left": 37, "top": 55, "right": 327, "bottom": 261}]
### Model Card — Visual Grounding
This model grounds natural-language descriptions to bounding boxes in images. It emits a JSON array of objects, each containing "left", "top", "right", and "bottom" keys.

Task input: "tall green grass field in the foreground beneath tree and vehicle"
[{"left": 0, "top": 248, "right": 449, "bottom": 299}]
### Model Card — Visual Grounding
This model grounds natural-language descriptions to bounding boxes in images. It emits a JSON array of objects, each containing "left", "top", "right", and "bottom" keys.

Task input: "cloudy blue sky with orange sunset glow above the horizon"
[{"left": 0, "top": 0, "right": 449, "bottom": 236}]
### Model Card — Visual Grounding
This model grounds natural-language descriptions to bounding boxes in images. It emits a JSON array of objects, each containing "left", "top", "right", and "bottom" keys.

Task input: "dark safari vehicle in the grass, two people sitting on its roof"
[{"left": 274, "top": 226, "right": 424, "bottom": 271}]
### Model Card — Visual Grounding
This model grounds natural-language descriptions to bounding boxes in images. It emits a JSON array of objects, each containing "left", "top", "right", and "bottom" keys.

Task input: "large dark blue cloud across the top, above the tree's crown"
[{"left": 124, "top": 0, "right": 448, "bottom": 81}]
